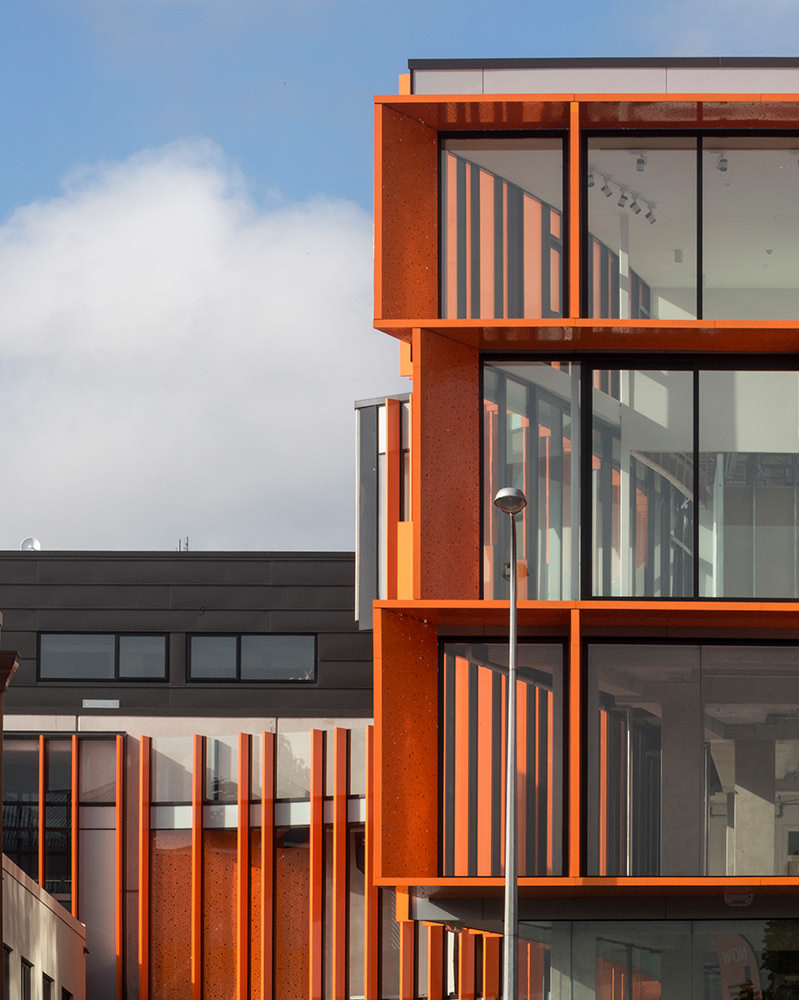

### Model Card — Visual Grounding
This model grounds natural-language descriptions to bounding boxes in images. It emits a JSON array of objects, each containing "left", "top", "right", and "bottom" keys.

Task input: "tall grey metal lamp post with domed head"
[{"left": 494, "top": 486, "right": 527, "bottom": 1000}]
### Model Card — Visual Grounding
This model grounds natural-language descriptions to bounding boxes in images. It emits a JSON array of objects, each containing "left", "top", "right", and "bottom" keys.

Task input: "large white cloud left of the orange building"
[{"left": 0, "top": 140, "right": 407, "bottom": 549}]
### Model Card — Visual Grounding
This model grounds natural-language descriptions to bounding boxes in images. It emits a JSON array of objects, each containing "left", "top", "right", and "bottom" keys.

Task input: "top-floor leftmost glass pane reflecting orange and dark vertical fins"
[{"left": 441, "top": 137, "right": 563, "bottom": 318}]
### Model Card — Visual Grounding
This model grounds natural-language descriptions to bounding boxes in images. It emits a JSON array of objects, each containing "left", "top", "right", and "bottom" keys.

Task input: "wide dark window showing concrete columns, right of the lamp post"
[{"left": 587, "top": 643, "right": 799, "bottom": 876}]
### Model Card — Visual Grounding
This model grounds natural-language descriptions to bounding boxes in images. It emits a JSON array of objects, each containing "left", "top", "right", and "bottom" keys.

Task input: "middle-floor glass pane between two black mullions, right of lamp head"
[{"left": 592, "top": 371, "right": 694, "bottom": 597}]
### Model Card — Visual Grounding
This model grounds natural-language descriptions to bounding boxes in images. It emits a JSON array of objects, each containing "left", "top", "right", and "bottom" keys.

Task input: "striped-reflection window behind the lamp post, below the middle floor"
[{"left": 441, "top": 643, "right": 563, "bottom": 876}]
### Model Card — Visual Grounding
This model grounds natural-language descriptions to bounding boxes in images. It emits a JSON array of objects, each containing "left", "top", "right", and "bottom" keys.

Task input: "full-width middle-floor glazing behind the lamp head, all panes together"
[{"left": 482, "top": 360, "right": 799, "bottom": 600}]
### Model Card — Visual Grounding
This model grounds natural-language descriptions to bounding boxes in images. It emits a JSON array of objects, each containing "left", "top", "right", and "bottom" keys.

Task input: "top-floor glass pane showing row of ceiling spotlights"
[{"left": 586, "top": 136, "right": 697, "bottom": 319}]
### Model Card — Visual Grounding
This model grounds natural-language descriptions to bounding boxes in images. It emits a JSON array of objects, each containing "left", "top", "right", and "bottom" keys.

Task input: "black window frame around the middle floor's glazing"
[{"left": 478, "top": 351, "right": 799, "bottom": 604}]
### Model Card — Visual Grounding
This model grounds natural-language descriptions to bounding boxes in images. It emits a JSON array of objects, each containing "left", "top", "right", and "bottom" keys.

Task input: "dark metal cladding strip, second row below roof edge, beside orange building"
[{"left": 170, "top": 585, "right": 354, "bottom": 613}]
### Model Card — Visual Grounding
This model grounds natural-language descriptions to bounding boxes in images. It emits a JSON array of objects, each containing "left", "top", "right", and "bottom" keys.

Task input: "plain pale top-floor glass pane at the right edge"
[{"left": 702, "top": 136, "right": 799, "bottom": 320}]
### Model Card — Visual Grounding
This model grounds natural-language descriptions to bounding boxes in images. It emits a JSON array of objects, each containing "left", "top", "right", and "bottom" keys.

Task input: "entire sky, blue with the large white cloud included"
[{"left": 0, "top": 0, "right": 799, "bottom": 549}]
